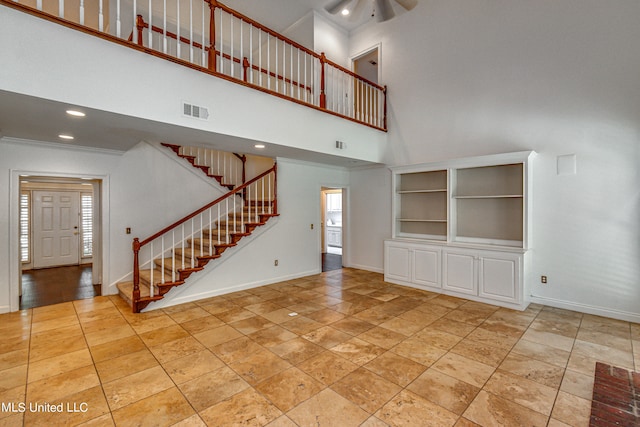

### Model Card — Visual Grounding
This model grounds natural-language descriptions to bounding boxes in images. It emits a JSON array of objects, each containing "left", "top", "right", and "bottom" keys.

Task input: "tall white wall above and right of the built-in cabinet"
[{"left": 350, "top": 0, "right": 640, "bottom": 321}]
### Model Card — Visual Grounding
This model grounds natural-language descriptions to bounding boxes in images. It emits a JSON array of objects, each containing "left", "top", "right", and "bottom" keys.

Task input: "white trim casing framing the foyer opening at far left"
[{"left": 8, "top": 167, "right": 111, "bottom": 311}]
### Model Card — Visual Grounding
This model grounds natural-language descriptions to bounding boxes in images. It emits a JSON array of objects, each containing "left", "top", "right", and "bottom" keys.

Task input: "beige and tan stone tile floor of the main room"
[{"left": 0, "top": 269, "right": 640, "bottom": 427}]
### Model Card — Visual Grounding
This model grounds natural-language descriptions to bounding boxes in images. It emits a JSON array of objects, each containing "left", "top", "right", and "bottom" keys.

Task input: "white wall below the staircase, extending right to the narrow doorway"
[{"left": 149, "top": 159, "right": 349, "bottom": 309}]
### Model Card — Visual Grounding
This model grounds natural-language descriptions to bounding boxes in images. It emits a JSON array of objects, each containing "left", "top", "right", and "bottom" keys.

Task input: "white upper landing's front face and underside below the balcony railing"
[{"left": 0, "top": 0, "right": 387, "bottom": 166}]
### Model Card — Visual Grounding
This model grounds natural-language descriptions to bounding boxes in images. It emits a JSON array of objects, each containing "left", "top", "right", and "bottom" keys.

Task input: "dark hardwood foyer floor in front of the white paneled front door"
[{"left": 20, "top": 264, "right": 100, "bottom": 310}]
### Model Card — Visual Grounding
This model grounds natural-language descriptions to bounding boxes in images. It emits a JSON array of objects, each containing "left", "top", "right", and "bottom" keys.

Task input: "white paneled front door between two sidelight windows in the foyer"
[{"left": 33, "top": 191, "right": 80, "bottom": 268}]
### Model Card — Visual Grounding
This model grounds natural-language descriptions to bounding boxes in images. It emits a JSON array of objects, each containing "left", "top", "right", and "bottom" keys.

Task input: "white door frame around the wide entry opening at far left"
[{"left": 9, "top": 169, "right": 109, "bottom": 312}]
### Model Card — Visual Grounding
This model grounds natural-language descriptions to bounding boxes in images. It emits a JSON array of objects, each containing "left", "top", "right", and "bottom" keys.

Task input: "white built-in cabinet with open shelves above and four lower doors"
[{"left": 384, "top": 151, "right": 535, "bottom": 310}]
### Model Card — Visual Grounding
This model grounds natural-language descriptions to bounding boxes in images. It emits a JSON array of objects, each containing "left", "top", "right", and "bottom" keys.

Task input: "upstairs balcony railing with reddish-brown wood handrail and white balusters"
[{"left": 0, "top": 0, "right": 387, "bottom": 130}]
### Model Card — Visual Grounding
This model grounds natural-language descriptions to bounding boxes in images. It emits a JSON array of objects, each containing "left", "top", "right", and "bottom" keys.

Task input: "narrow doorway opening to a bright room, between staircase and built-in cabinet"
[{"left": 320, "top": 187, "right": 344, "bottom": 271}]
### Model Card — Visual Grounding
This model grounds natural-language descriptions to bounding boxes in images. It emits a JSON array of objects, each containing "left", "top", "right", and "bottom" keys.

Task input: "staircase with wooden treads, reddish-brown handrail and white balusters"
[{"left": 117, "top": 144, "right": 278, "bottom": 313}]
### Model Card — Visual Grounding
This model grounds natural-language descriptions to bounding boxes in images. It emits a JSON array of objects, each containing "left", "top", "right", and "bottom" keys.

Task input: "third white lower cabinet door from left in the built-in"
[{"left": 442, "top": 251, "right": 478, "bottom": 295}]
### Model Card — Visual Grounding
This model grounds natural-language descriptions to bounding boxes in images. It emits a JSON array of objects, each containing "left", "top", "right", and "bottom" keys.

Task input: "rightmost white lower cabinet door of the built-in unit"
[{"left": 479, "top": 253, "right": 522, "bottom": 303}]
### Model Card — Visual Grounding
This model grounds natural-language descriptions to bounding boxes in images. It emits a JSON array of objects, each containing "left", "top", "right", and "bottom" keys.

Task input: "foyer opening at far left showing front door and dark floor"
[{"left": 19, "top": 176, "right": 102, "bottom": 310}]
